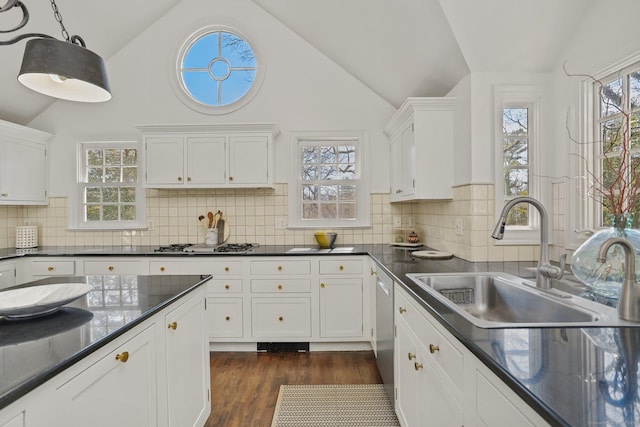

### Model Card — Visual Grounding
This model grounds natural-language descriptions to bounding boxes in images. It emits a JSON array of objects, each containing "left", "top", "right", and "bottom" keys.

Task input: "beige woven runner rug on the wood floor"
[{"left": 271, "top": 384, "right": 400, "bottom": 427}]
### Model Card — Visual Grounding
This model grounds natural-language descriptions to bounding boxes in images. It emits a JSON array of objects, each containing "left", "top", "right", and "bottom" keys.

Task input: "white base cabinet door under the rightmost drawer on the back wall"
[{"left": 320, "top": 279, "right": 363, "bottom": 338}]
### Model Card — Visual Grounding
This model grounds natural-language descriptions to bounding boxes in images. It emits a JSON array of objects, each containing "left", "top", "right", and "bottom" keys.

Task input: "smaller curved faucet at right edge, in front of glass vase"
[{"left": 597, "top": 237, "right": 640, "bottom": 322}]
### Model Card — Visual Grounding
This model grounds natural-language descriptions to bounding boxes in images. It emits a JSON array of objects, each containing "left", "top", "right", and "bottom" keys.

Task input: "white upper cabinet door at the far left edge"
[{"left": 0, "top": 139, "right": 47, "bottom": 204}]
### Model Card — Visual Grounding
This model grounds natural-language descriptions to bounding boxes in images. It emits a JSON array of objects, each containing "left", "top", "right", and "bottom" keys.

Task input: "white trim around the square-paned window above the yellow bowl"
[{"left": 288, "top": 131, "right": 371, "bottom": 229}]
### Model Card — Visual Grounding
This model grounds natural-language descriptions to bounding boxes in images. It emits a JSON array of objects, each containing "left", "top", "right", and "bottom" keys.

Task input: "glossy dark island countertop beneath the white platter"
[{"left": 0, "top": 276, "right": 211, "bottom": 409}]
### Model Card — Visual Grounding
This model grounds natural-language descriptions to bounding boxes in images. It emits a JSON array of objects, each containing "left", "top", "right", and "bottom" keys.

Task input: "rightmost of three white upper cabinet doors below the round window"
[{"left": 229, "top": 136, "right": 273, "bottom": 185}]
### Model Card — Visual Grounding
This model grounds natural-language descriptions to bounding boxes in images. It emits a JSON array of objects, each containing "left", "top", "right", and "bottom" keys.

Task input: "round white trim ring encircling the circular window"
[{"left": 169, "top": 25, "right": 267, "bottom": 115}]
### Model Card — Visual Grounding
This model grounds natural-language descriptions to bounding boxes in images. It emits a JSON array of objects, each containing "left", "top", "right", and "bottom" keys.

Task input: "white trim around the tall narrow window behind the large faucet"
[{"left": 493, "top": 86, "right": 552, "bottom": 246}]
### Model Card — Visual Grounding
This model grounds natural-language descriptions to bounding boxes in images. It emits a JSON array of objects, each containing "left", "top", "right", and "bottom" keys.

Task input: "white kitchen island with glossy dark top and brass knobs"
[{"left": 0, "top": 275, "right": 210, "bottom": 427}]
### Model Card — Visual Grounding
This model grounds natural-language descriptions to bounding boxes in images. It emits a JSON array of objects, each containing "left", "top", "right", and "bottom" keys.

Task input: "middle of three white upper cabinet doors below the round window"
[{"left": 187, "top": 136, "right": 227, "bottom": 185}]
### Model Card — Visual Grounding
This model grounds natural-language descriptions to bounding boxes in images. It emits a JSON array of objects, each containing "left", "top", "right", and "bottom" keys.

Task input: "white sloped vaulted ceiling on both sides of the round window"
[{"left": 0, "top": 0, "right": 593, "bottom": 124}]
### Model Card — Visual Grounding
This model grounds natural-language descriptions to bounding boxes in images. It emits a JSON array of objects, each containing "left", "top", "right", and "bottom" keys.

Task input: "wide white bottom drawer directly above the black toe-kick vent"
[{"left": 251, "top": 298, "right": 311, "bottom": 338}]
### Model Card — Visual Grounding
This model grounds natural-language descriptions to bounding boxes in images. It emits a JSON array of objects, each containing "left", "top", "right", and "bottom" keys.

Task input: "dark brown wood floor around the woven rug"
[{"left": 206, "top": 351, "right": 382, "bottom": 427}]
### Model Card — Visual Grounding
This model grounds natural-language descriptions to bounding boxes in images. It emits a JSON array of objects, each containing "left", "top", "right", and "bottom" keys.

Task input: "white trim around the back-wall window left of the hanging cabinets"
[{"left": 69, "top": 140, "right": 147, "bottom": 231}]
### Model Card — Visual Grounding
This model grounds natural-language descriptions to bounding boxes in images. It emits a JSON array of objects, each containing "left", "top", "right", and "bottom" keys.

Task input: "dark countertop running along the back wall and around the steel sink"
[{"left": 0, "top": 244, "right": 640, "bottom": 426}]
